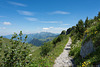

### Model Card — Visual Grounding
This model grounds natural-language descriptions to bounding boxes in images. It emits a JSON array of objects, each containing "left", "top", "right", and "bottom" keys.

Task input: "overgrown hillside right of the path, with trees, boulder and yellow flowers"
[{"left": 66, "top": 12, "right": 100, "bottom": 67}]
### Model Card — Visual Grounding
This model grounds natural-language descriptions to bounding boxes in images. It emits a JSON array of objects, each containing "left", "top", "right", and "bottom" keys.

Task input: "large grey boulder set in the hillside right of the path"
[{"left": 80, "top": 39, "right": 94, "bottom": 58}]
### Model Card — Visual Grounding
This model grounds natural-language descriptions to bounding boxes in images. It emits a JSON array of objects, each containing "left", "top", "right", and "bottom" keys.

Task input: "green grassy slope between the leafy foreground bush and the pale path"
[{"left": 31, "top": 36, "right": 68, "bottom": 67}]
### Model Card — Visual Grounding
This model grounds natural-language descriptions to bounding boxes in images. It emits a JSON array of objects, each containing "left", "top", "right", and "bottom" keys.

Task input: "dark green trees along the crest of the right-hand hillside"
[{"left": 61, "top": 12, "right": 100, "bottom": 39}]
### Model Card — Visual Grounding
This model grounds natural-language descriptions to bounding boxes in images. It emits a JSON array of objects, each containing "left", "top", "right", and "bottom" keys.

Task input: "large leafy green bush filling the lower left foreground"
[{"left": 0, "top": 32, "right": 31, "bottom": 67}]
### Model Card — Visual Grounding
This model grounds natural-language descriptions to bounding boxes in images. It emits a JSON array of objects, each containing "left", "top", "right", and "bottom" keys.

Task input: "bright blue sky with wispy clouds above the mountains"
[{"left": 0, "top": 0, "right": 100, "bottom": 35}]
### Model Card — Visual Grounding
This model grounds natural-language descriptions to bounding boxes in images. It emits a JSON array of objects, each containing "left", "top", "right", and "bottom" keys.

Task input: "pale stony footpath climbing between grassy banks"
[{"left": 53, "top": 37, "right": 73, "bottom": 67}]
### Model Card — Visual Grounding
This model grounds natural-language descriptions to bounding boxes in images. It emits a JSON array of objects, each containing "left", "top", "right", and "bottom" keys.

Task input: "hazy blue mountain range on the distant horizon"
[{"left": 3, "top": 32, "right": 59, "bottom": 46}]
